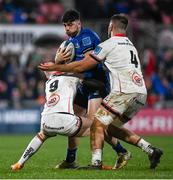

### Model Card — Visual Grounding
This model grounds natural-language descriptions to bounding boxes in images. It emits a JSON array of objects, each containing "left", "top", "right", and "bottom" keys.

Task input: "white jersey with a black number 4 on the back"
[{"left": 91, "top": 36, "right": 147, "bottom": 94}]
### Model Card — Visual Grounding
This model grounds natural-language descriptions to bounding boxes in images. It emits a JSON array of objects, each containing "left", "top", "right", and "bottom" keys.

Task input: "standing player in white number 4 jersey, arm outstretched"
[{"left": 39, "top": 14, "right": 163, "bottom": 169}]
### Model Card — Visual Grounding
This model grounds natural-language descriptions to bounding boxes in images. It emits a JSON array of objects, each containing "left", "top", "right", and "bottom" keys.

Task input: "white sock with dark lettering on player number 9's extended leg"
[{"left": 18, "top": 136, "right": 43, "bottom": 164}]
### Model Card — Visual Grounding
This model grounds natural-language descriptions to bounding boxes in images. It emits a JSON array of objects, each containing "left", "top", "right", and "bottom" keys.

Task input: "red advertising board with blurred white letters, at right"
[{"left": 125, "top": 109, "right": 173, "bottom": 135}]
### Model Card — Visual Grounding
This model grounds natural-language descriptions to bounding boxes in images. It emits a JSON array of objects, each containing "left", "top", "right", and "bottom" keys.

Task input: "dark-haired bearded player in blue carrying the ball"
[{"left": 53, "top": 10, "right": 131, "bottom": 169}]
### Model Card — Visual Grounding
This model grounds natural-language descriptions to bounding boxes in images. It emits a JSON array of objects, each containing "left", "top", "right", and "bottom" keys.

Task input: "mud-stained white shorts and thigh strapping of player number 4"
[{"left": 95, "top": 93, "right": 147, "bottom": 127}]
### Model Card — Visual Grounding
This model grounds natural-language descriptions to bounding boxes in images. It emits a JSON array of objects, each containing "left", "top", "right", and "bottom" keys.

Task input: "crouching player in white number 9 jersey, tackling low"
[{"left": 11, "top": 68, "right": 92, "bottom": 171}]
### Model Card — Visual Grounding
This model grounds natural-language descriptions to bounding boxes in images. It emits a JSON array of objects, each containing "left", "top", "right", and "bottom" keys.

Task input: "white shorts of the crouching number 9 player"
[{"left": 40, "top": 113, "right": 82, "bottom": 136}]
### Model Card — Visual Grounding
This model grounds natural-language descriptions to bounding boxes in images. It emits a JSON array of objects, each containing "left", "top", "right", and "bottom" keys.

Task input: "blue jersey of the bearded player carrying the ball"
[{"left": 68, "top": 28, "right": 109, "bottom": 99}]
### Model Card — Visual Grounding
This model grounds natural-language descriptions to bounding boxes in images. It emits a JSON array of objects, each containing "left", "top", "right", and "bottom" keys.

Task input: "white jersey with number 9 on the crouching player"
[{"left": 42, "top": 75, "right": 79, "bottom": 115}]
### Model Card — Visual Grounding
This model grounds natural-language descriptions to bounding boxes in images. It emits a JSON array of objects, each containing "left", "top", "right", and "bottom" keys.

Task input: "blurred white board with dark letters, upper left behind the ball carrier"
[{"left": 0, "top": 25, "right": 65, "bottom": 51}]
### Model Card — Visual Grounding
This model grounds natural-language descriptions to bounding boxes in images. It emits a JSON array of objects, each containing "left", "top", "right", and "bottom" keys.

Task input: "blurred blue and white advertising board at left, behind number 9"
[{"left": 0, "top": 109, "right": 40, "bottom": 134}]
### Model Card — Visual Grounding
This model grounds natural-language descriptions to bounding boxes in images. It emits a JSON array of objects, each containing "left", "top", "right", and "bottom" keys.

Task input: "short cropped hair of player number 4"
[{"left": 111, "top": 14, "right": 128, "bottom": 30}]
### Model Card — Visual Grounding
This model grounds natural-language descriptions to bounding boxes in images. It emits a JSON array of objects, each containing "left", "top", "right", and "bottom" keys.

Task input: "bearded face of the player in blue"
[{"left": 64, "top": 21, "right": 81, "bottom": 37}]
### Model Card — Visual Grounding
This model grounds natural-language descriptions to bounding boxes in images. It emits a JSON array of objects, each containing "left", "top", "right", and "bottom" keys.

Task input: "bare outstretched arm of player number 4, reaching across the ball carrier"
[{"left": 38, "top": 55, "right": 98, "bottom": 73}]
